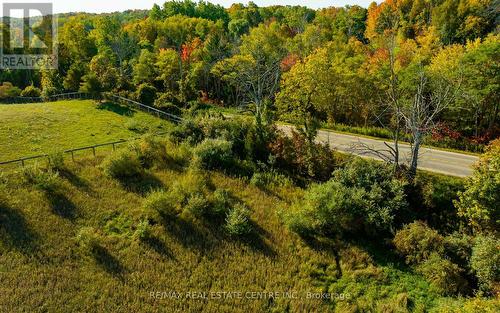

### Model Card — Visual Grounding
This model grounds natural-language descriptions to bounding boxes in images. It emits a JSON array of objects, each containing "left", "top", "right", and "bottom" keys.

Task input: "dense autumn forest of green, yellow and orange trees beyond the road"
[{"left": 0, "top": 0, "right": 500, "bottom": 151}]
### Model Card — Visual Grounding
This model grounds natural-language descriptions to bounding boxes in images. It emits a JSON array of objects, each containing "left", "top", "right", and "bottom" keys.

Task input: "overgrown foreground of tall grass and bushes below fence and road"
[{"left": 0, "top": 117, "right": 499, "bottom": 312}]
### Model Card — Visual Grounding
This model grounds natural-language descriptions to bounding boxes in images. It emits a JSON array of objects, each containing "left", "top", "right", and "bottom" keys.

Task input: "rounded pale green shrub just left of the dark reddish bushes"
[{"left": 193, "top": 139, "right": 234, "bottom": 170}]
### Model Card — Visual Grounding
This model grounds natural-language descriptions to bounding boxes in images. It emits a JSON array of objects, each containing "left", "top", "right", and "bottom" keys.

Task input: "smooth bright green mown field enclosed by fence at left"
[{"left": 0, "top": 100, "right": 169, "bottom": 161}]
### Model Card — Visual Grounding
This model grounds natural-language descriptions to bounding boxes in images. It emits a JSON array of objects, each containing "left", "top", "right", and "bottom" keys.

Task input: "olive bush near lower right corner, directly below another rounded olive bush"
[{"left": 417, "top": 253, "right": 467, "bottom": 295}]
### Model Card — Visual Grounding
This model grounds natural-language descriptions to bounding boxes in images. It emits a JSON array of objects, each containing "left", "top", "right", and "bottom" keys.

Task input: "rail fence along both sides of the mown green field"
[{"left": 0, "top": 92, "right": 184, "bottom": 166}]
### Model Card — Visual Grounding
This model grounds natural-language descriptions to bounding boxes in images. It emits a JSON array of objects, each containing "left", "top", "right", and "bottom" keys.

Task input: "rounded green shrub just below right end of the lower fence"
[{"left": 101, "top": 150, "right": 144, "bottom": 180}]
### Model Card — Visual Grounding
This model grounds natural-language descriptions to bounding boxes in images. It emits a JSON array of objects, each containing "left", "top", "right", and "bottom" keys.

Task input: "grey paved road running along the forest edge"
[{"left": 279, "top": 125, "right": 478, "bottom": 177}]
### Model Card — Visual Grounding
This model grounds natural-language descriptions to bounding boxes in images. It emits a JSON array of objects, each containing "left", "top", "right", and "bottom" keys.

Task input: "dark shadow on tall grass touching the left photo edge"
[{"left": 0, "top": 201, "right": 38, "bottom": 255}]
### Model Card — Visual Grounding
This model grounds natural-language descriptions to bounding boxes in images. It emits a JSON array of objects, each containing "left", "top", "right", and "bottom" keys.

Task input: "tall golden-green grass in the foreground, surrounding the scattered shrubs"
[{"left": 0, "top": 158, "right": 476, "bottom": 312}]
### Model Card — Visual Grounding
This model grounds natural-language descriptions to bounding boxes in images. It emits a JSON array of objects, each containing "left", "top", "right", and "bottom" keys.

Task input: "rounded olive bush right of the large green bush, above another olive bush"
[{"left": 393, "top": 221, "right": 444, "bottom": 264}]
